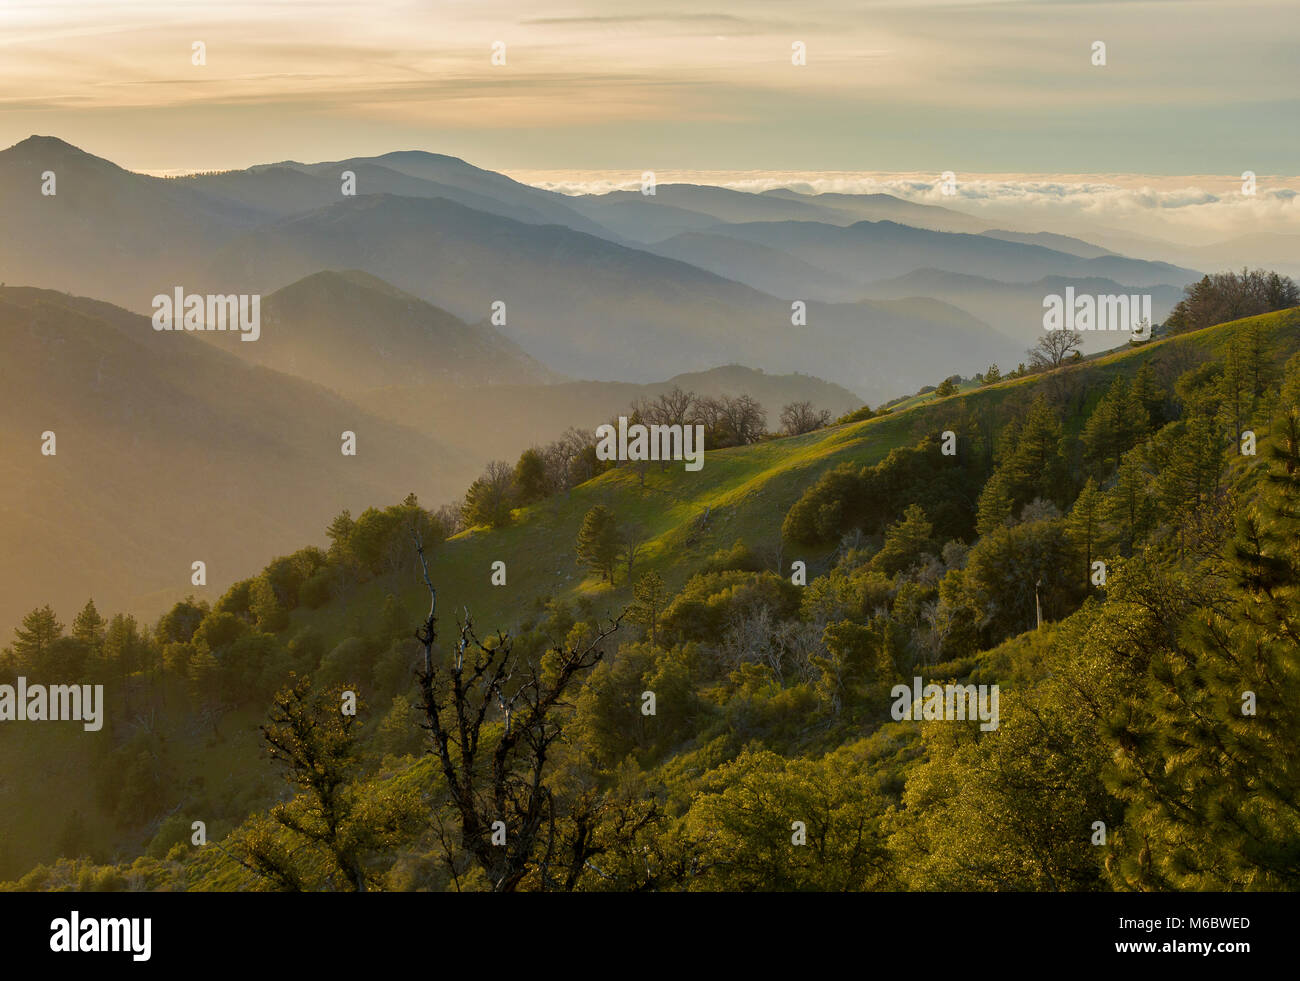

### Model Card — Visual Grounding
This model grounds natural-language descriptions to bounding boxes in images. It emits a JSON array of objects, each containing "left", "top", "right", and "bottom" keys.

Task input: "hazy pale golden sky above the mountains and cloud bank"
[{"left": 0, "top": 0, "right": 1300, "bottom": 175}]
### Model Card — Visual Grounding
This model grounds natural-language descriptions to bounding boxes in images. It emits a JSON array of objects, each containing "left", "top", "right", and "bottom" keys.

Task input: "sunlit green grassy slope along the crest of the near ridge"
[{"left": 361, "top": 311, "right": 1300, "bottom": 641}]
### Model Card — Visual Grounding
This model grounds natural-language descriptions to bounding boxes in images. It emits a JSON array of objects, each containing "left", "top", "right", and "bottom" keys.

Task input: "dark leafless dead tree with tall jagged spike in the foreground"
[{"left": 415, "top": 538, "right": 623, "bottom": 893}]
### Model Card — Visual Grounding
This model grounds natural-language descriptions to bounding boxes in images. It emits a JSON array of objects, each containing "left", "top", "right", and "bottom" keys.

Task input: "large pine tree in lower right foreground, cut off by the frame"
[{"left": 1109, "top": 416, "right": 1300, "bottom": 890}]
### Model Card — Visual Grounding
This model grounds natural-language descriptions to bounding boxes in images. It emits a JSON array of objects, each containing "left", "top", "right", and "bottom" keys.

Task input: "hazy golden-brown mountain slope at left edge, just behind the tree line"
[{"left": 0, "top": 286, "right": 477, "bottom": 636}]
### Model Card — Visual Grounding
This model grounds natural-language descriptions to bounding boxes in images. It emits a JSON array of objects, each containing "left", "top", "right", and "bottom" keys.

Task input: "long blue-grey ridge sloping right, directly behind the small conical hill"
[{"left": 191, "top": 195, "right": 1024, "bottom": 400}]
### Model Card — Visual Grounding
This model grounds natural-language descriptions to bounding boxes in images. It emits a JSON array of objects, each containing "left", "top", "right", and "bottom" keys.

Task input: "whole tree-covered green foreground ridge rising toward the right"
[{"left": 7, "top": 312, "right": 1300, "bottom": 890}]
